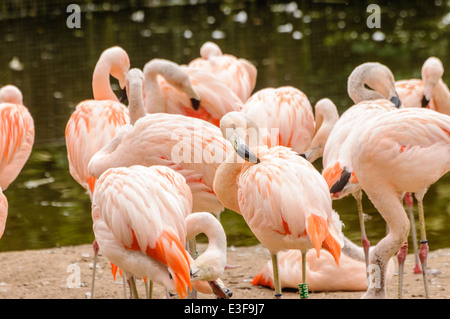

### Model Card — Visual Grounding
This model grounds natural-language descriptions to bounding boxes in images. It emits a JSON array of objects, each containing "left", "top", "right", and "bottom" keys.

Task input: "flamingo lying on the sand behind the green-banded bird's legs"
[{"left": 252, "top": 249, "right": 395, "bottom": 291}]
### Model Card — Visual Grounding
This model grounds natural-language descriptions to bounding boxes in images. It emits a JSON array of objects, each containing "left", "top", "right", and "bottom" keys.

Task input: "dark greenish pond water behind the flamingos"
[{"left": 0, "top": 1, "right": 450, "bottom": 251}]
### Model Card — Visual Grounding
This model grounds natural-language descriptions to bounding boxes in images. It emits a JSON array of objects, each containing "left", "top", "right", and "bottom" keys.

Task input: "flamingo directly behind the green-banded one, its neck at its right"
[{"left": 242, "top": 86, "right": 339, "bottom": 161}]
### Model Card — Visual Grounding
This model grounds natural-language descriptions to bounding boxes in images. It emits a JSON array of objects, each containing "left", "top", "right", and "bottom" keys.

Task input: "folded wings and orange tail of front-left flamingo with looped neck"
[{"left": 94, "top": 166, "right": 192, "bottom": 297}]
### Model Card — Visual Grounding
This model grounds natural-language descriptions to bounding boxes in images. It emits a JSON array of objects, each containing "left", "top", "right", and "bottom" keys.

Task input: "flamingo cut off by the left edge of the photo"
[{"left": 0, "top": 85, "right": 34, "bottom": 238}]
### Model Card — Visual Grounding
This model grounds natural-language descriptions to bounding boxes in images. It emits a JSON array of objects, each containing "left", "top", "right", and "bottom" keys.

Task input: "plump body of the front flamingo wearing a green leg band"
[{"left": 238, "top": 146, "right": 342, "bottom": 263}]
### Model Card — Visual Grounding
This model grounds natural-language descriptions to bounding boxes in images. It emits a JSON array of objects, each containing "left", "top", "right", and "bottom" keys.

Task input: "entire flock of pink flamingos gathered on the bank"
[{"left": 0, "top": 42, "right": 450, "bottom": 299}]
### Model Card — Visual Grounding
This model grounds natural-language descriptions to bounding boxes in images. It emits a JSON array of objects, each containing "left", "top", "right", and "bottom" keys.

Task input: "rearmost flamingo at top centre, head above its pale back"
[{"left": 188, "top": 41, "right": 258, "bottom": 103}]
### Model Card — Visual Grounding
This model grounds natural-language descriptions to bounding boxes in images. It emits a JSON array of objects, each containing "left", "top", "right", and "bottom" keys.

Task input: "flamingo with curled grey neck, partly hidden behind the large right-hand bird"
[{"left": 322, "top": 63, "right": 401, "bottom": 276}]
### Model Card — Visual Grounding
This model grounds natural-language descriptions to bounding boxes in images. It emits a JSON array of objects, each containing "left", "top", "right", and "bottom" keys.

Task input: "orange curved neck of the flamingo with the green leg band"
[{"left": 213, "top": 152, "right": 244, "bottom": 214}]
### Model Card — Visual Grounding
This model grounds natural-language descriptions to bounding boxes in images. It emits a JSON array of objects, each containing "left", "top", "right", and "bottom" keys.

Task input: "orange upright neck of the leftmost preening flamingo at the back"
[{"left": 92, "top": 58, "right": 119, "bottom": 102}]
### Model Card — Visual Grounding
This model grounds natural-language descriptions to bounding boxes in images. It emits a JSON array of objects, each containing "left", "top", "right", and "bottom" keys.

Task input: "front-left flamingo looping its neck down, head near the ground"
[{"left": 92, "top": 165, "right": 230, "bottom": 299}]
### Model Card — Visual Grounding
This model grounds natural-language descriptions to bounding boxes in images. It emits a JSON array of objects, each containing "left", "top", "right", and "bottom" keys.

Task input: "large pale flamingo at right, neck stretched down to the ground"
[{"left": 351, "top": 108, "right": 450, "bottom": 298}]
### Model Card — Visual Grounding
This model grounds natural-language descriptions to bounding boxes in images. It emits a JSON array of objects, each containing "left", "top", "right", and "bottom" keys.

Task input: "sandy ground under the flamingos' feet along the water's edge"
[{"left": 0, "top": 245, "right": 450, "bottom": 299}]
